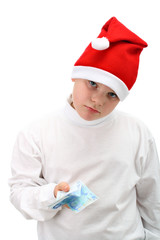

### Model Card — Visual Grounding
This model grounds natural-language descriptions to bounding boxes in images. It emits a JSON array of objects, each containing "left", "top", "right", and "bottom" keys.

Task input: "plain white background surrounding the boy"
[{"left": 0, "top": 0, "right": 160, "bottom": 240}]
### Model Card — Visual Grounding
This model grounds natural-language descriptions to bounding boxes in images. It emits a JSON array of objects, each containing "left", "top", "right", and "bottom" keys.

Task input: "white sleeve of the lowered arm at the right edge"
[{"left": 136, "top": 140, "right": 160, "bottom": 240}]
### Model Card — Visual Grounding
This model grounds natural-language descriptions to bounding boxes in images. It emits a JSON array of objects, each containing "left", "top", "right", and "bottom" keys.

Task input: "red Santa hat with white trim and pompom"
[{"left": 72, "top": 17, "right": 147, "bottom": 101}]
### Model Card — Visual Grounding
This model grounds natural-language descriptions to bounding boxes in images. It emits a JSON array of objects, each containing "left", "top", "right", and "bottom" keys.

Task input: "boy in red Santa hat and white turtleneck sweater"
[{"left": 10, "top": 17, "right": 160, "bottom": 240}]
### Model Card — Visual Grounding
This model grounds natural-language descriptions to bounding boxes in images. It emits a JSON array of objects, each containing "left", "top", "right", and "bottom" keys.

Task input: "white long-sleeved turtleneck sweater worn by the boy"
[{"left": 9, "top": 96, "right": 160, "bottom": 240}]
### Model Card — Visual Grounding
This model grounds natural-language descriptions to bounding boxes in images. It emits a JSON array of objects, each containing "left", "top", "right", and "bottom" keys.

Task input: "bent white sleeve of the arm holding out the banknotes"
[{"left": 9, "top": 125, "right": 58, "bottom": 221}]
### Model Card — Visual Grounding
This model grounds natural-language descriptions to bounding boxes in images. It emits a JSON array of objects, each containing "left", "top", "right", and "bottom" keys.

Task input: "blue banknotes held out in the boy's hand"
[{"left": 49, "top": 180, "right": 99, "bottom": 213}]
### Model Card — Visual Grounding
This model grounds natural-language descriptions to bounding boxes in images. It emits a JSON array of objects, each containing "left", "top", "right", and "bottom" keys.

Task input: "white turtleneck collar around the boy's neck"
[{"left": 64, "top": 95, "right": 116, "bottom": 127}]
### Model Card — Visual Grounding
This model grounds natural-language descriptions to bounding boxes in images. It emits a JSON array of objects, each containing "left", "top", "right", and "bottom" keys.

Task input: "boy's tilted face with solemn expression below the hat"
[{"left": 72, "top": 79, "right": 120, "bottom": 121}]
